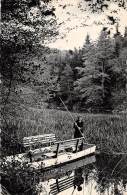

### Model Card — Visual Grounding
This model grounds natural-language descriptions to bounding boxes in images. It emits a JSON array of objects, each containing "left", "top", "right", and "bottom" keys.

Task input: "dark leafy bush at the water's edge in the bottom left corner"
[{"left": 1, "top": 157, "right": 41, "bottom": 195}]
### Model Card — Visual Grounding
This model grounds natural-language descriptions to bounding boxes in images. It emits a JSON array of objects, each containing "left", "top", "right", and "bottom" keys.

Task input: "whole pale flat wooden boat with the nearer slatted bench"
[{"left": 7, "top": 137, "right": 96, "bottom": 170}]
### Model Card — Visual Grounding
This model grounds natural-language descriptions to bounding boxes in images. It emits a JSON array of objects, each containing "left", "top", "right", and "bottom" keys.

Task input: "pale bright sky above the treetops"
[{"left": 48, "top": 0, "right": 127, "bottom": 50}]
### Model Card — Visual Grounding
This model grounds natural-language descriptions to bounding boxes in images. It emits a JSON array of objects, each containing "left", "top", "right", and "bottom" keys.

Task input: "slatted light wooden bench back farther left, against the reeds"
[{"left": 23, "top": 134, "right": 56, "bottom": 150}]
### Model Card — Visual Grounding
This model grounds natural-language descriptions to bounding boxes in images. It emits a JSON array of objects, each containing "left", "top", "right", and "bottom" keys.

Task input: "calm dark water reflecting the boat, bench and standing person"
[{"left": 40, "top": 155, "right": 127, "bottom": 195}]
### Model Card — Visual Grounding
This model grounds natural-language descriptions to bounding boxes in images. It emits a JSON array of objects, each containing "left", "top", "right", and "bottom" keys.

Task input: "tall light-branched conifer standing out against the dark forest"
[{"left": 76, "top": 31, "right": 114, "bottom": 111}]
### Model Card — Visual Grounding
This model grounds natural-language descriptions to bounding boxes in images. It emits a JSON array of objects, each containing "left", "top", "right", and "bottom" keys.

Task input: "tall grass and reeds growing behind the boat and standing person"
[{"left": 3, "top": 109, "right": 127, "bottom": 153}]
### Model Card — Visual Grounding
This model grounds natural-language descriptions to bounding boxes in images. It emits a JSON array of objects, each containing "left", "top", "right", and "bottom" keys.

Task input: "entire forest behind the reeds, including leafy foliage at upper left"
[{"left": 1, "top": 0, "right": 127, "bottom": 122}]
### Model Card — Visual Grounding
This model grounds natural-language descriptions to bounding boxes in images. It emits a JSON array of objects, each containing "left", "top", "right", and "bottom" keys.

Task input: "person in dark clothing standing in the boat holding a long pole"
[{"left": 74, "top": 116, "right": 83, "bottom": 138}]
